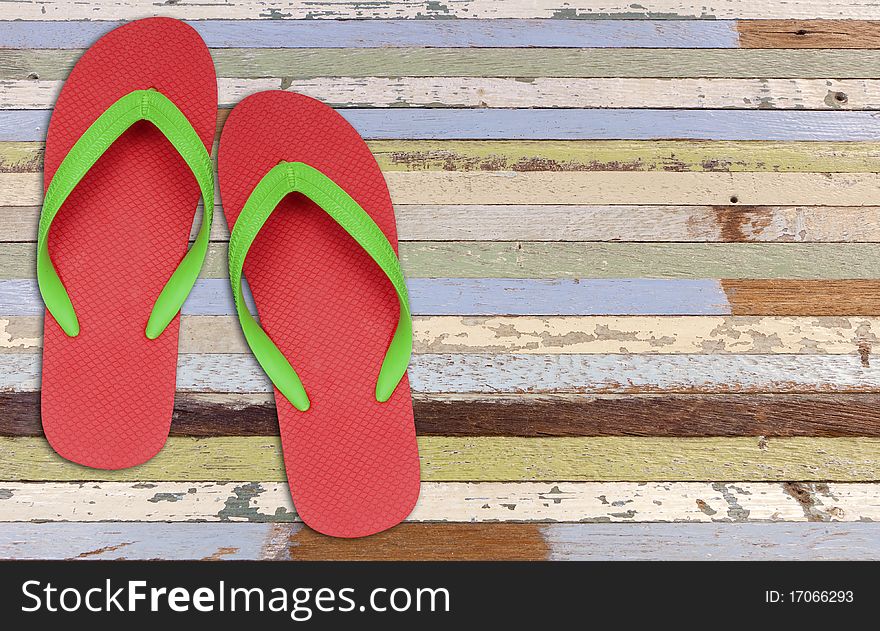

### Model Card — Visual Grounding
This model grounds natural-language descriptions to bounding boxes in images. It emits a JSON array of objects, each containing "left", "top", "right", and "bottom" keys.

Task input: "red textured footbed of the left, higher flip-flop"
[{"left": 42, "top": 18, "right": 217, "bottom": 469}]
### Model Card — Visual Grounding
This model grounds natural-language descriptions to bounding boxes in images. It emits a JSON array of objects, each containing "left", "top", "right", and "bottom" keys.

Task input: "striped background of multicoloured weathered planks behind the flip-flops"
[{"left": 0, "top": 0, "right": 880, "bottom": 559}]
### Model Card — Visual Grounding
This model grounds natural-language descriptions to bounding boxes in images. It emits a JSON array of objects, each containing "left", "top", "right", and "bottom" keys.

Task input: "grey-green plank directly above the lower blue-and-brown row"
[{"left": 6, "top": 242, "right": 880, "bottom": 280}]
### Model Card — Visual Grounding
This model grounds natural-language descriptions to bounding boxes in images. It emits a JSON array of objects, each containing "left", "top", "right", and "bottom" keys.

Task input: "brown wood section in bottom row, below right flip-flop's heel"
[{"left": 286, "top": 523, "right": 550, "bottom": 561}]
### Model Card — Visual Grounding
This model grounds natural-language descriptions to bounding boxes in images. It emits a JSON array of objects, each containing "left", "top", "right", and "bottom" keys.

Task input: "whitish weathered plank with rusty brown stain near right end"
[{"left": 8, "top": 204, "right": 880, "bottom": 243}]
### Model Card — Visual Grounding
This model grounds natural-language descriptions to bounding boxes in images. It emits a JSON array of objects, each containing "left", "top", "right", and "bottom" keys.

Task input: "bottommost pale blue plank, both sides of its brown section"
[{"left": 0, "top": 522, "right": 880, "bottom": 561}]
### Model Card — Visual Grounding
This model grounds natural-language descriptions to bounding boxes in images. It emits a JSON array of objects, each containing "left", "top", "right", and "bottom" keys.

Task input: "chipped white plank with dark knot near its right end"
[{"left": 6, "top": 77, "right": 880, "bottom": 110}]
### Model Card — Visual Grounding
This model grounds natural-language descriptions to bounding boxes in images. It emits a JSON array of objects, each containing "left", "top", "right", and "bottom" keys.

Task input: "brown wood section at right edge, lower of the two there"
[{"left": 721, "top": 279, "right": 880, "bottom": 316}]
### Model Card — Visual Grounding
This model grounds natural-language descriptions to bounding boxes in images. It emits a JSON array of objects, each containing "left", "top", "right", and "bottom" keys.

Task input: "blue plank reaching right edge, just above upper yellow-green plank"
[{"left": 0, "top": 108, "right": 880, "bottom": 141}]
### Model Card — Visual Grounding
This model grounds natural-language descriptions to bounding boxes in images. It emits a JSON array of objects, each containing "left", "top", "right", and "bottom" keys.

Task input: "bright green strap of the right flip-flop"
[{"left": 229, "top": 162, "right": 412, "bottom": 412}]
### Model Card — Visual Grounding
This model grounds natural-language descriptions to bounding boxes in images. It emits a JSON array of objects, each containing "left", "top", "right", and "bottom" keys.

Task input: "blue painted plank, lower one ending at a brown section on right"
[{"left": 0, "top": 278, "right": 731, "bottom": 317}]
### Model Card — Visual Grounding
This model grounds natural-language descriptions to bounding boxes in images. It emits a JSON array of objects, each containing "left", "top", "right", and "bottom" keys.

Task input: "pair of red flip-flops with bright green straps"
[{"left": 37, "top": 18, "right": 419, "bottom": 537}]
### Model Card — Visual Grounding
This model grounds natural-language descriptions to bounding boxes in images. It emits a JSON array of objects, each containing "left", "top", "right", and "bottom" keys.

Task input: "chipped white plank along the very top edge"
[{"left": 3, "top": 0, "right": 880, "bottom": 20}]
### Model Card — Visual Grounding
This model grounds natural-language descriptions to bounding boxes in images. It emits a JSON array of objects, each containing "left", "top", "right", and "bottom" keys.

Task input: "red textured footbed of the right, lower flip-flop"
[{"left": 218, "top": 91, "right": 419, "bottom": 537}]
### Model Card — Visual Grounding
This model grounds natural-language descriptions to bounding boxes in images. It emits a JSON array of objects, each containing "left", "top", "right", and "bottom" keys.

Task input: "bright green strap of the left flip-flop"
[{"left": 37, "top": 90, "right": 214, "bottom": 339}]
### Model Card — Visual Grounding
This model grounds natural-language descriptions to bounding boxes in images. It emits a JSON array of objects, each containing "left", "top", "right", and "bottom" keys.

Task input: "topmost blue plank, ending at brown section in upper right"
[{"left": 0, "top": 19, "right": 739, "bottom": 48}]
